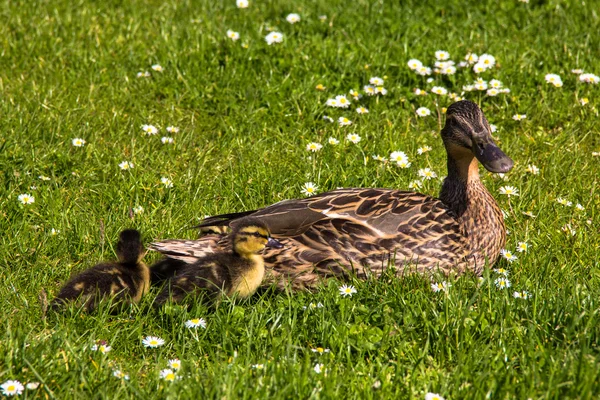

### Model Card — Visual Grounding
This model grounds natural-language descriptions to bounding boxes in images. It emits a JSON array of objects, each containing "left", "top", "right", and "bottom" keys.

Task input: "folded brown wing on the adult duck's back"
[{"left": 199, "top": 188, "right": 456, "bottom": 238}]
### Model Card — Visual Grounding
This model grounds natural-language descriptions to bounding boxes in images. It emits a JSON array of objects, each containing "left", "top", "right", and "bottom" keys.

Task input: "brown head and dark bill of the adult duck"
[{"left": 442, "top": 100, "right": 513, "bottom": 173}]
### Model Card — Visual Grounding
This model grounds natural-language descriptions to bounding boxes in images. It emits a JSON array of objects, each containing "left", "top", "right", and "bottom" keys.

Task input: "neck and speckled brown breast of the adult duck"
[{"left": 440, "top": 155, "right": 506, "bottom": 272}]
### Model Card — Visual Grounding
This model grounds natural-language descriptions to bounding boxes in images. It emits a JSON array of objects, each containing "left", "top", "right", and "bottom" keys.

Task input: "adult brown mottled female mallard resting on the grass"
[{"left": 151, "top": 100, "right": 513, "bottom": 289}]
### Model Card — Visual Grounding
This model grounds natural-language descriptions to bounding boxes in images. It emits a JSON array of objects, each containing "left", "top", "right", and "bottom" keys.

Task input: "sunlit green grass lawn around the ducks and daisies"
[{"left": 0, "top": 0, "right": 600, "bottom": 399}]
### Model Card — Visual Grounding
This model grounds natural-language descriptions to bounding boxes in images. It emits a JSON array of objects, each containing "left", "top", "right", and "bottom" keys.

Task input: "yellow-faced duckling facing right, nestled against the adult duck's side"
[{"left": 155, "top": 218, "right": 283, "bottom": 307}]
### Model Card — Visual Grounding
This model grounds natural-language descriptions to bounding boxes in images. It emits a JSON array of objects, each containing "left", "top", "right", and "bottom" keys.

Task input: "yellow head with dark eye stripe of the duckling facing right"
[{"left": 231, "top": 218, "right": 283, "bottom": 256}]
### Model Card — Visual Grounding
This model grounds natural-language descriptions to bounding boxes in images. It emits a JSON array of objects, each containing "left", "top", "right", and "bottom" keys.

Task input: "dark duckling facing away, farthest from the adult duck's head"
[{"left": 52, "top": 229, "right": 150, "bottom": 311}]
